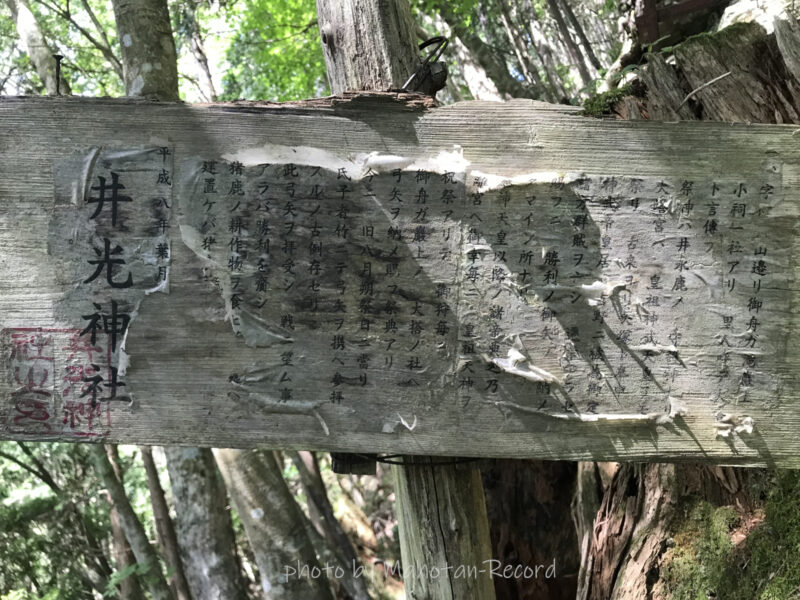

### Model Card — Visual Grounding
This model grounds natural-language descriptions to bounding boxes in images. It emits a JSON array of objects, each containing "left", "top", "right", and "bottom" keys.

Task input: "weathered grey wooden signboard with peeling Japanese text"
[{"left": 0, "top": 95, "right": 800, "bottom": 464}]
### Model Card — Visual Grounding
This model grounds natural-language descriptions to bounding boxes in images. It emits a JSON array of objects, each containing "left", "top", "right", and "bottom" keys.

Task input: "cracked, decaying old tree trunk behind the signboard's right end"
[{"left": 578, "top": 17, "right": 800, "bottom": 600}]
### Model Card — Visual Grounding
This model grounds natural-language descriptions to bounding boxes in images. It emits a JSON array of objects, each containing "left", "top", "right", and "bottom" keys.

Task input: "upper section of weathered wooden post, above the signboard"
[{"left": 317, "top": 0, "right": 420, "bottom": 94}]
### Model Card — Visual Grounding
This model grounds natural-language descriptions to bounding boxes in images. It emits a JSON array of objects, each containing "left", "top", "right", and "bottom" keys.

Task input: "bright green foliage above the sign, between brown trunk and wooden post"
[{"left": 220, "top": 0, "right": 329, "bottom": 101}]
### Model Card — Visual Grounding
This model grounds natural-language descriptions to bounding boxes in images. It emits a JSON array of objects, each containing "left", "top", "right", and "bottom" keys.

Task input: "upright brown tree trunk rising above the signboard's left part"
[{"left": 112, "top": 0, "right": 179, "bottom": 100}]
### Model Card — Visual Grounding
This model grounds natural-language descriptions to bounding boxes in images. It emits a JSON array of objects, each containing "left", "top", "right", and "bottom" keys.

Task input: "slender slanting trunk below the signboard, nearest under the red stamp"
[{"left": 90, "top": 445, "right": 172, "bottom": 600}]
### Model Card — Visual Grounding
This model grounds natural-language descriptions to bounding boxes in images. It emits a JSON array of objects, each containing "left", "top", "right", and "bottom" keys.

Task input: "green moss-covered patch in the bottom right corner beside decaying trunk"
[{"left": 661, "top": 471, "right": 800, "bottom": 600}]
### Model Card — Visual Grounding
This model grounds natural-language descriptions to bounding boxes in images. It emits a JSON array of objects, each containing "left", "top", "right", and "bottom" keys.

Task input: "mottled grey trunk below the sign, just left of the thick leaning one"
[{"left": 164, "top": 447, "right": 247, "bottom": 600}]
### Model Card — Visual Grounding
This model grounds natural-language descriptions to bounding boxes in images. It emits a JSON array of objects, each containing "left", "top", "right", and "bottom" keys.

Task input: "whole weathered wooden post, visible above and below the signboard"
[{"left": 317, "top": 0, "right": 494, "bottom": 600}]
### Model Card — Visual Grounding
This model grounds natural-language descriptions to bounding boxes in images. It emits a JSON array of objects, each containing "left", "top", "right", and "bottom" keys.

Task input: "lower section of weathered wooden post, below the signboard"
[{"left": 392, "top": 456, "right": 502, "bottom": 600}]
